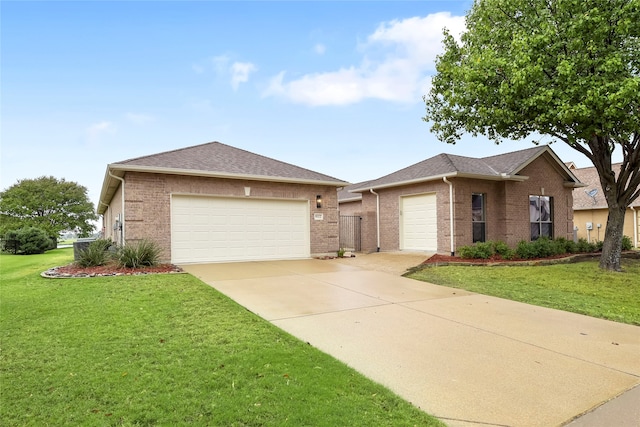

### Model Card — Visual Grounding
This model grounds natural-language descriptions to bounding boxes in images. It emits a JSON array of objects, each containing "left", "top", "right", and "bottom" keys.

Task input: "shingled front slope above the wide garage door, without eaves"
[{"left": 110, "top": 142, "right": 344, "bottom": 184}]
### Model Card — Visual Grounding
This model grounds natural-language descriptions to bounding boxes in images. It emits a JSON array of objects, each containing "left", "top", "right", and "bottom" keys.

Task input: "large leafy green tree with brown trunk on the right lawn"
[{"left": 424, "top": 0, "right": 640, "bottom": 270}]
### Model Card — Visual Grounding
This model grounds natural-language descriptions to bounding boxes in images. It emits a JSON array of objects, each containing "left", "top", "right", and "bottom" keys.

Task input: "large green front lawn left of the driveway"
[{"left": 0, "top": 248, "right": 442, "bottom": 426}]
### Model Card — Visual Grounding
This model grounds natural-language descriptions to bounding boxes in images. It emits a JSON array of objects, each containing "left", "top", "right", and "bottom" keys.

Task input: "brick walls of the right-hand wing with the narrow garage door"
[{"left": 356, "top": 156, "right": 573, "bottom": 254}]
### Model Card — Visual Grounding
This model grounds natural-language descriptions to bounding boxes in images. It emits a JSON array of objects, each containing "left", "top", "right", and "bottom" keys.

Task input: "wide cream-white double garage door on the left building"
[{"left": 171, "top": 195, "right": 310, "bottom": 264}]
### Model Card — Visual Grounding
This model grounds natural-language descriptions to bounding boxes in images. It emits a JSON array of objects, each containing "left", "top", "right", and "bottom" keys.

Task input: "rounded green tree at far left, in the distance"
[{"left": 0, "top": 176, "right": 98, "bottom": 237}]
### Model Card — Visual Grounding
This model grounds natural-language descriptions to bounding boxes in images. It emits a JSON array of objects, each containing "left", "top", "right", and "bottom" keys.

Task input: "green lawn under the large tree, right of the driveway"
[{"left": 407, "top": 259, "right": 640, "bottom": 325}]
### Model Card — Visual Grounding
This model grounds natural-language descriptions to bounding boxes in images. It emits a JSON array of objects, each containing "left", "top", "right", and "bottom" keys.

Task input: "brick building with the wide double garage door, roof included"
[{"left": 98, "top": 142, "right": 347, "bottom": 263}]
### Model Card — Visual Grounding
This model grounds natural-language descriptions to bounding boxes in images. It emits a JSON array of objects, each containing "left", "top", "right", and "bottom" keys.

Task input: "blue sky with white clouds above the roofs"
[{"left": 0, "top": 1, "right": 590, "bottom": 212}]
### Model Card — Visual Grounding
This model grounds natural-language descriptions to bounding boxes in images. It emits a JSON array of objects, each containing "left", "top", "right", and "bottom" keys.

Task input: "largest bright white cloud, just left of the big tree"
[{"left": 262, "top": 12, "right": 464, "bottom": 106}]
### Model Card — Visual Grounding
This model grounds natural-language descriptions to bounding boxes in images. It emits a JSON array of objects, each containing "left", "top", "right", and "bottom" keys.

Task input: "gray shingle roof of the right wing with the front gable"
[{"left": 350, "top": 145, "right": 581, "bottom": 192}]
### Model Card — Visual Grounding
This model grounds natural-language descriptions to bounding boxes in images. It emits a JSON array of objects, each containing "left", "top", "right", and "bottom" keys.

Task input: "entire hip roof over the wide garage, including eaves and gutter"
[{"left": 98, "top": 142, "right": 347, "bottom": 213}]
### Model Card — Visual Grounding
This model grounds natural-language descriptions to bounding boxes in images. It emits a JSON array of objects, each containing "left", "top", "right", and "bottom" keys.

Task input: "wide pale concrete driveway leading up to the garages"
[{"left": 182, "top": 256, "right": 640, "bottom": 426}]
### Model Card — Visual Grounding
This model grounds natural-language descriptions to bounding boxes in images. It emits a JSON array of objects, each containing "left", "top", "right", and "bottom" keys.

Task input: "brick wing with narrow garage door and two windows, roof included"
[{"left": 340, "top": 146, "right": 582, "bottom": 254}]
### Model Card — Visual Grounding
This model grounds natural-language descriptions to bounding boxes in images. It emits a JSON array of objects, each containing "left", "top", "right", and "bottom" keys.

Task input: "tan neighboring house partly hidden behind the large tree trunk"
[{"left": 569, "top": 163, "right": 640, "bottom": 247}]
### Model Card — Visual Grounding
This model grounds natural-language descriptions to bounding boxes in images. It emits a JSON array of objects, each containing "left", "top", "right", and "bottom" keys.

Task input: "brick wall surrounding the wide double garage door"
[{"left": 105, "top": 172, "right": 339, "bottom": 262}]
